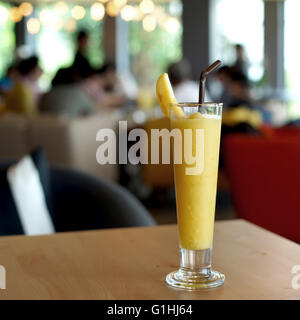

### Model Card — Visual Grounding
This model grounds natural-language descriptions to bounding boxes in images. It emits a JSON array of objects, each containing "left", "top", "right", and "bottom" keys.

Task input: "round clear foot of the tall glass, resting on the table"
[{"left": 166, "top": 269, "right": 225, "bottom": 290}]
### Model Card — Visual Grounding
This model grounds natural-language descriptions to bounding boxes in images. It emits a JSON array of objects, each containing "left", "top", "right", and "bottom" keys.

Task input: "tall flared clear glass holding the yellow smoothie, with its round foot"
[{"left": 166, "top": 103, "right": 225, "bottom": 290}]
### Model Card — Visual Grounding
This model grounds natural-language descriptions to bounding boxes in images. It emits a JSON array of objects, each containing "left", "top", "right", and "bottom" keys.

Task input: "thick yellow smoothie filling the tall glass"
[{"left": 171, "top": 111, "right": 221, "bottom": 250}]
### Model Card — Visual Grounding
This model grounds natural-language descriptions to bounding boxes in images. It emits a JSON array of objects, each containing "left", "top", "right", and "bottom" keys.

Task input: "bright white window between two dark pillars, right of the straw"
[{"left": 212, "top": 0, "right": 264, "bottom": 81}]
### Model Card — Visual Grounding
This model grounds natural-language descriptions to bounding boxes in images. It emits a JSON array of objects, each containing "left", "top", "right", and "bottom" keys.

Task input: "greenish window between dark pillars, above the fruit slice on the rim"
[{"left": 129, "top": 1, "right": 182, "bottom": 87}]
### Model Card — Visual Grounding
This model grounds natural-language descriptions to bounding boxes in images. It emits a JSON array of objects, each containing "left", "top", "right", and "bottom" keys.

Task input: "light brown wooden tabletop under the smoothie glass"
[{"left": 0, "top": 220, "right": 300, "bottom": 299}]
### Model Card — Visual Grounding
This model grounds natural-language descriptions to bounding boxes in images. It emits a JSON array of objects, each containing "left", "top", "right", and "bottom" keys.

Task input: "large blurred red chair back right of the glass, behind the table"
[{"left": 222, "top": 130, "right": 300, "bottom": 242}]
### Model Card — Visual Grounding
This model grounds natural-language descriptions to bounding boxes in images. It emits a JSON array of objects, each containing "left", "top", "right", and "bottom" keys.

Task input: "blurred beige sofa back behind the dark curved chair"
[{"left": 0, "top": 112, "right": 120, "bottom": 181}]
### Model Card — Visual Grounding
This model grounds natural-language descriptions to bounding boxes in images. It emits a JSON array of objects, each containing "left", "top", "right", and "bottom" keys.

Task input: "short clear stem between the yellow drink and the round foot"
[{"left": 180, "top": 248, "right": 212, "bottom": 277}]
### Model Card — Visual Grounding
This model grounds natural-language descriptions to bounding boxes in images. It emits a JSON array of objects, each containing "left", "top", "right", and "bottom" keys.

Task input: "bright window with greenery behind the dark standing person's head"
[{"left": 36, "top": 5, "right": 103, "bottom": 86}]
